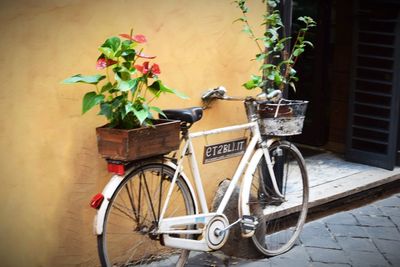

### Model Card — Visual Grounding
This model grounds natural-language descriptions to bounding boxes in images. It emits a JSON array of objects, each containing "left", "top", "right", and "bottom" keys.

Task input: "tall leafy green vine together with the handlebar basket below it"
[{"left": 234, "top": 0, "right": 316, "bottom": 135}]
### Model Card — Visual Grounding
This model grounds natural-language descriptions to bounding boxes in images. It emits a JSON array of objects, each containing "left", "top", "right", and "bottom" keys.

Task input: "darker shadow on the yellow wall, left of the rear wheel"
[{"left": 50, "top": 135, "right": 110, "bottom": 267}]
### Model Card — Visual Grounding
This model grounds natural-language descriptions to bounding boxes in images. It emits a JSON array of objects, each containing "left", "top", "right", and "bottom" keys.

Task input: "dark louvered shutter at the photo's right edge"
[{"left": 346, "top": 0, "right": 400, "bottom": 169}]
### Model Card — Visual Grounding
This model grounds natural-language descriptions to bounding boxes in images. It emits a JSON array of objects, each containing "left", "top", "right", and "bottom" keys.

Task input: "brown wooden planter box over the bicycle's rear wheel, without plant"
[{"left": 96, "top": 120, "right": 180, "bottom": 161}]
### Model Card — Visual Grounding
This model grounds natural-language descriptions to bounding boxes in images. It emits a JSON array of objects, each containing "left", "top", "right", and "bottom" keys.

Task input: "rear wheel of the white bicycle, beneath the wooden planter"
[{"left": 97, "top": 163, "right": 195, "bottom": 267}]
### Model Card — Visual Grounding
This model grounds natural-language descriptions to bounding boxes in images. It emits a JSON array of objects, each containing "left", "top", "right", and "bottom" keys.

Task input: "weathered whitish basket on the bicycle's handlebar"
[{"left": 257, "top": 99, "right": 308, "bottom": 136}]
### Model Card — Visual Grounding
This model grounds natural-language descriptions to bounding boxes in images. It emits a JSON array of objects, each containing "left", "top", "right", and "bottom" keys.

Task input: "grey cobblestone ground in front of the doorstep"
[{"left": 188, "top": 194, "right": 400, "bottom": 267}]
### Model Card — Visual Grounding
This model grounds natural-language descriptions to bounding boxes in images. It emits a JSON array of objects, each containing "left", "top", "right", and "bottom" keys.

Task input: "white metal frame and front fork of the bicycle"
[{"left": 157, "top": 121, "right": 282, "bottom": 251}]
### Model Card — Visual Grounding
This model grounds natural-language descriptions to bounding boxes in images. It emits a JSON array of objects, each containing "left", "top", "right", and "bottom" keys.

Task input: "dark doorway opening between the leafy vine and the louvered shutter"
[{"left": 289, "top": 0, "right": 331, "bottom": 146}]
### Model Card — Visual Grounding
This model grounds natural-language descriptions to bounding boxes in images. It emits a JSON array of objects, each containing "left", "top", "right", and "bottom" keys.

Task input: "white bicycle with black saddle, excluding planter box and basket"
[{"left": 94, "top": 87, "right": 309, "bottom": 267}]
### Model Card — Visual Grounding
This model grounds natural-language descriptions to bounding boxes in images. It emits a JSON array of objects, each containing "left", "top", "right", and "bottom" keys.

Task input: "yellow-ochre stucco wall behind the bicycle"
[{"left": 0, "top": 0, "right": 263, "bottom": 267}]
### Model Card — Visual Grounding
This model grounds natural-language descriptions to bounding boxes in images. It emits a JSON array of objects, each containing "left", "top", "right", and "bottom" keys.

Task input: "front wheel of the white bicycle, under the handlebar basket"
[{"left": 242, "top": 141, "right": 309, "bottom": 256}]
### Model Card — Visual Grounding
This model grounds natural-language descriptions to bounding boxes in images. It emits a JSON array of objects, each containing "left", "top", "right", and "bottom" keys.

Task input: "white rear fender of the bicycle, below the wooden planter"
[{"left": 93, "top": 161, "right": 198, "bottom": 235}]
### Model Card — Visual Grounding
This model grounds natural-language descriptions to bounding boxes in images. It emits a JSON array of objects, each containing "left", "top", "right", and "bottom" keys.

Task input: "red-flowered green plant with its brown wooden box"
[{"left": 63, "top": 30, "right": 186, "bottom": 160}]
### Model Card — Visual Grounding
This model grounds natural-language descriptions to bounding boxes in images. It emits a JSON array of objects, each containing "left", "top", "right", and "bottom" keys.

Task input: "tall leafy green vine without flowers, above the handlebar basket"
[{"left": 235, "top": 0, "right": 316, "bottom": 97}]
